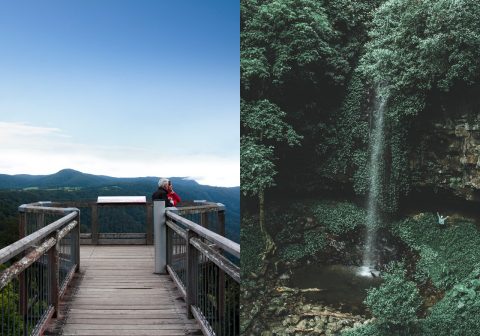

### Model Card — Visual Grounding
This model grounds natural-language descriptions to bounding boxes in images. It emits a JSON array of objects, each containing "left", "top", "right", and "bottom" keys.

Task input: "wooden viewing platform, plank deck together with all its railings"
[{"left": 0, "top": 199, "right": 240, "bottom": 336}]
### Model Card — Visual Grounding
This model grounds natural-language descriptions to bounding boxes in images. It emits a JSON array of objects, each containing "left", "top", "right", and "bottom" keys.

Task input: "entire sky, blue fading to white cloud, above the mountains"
[{"left": 0, "top": 0, "right": 240, "bottom": 186}]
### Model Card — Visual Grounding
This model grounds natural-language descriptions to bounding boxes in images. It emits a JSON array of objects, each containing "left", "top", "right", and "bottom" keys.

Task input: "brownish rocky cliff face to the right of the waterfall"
[{"left": 410, "top": 105, "right": 480, "bottom": 202}]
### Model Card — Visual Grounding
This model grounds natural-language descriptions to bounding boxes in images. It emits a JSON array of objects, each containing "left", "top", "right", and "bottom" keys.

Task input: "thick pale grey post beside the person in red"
[{"left": 153, "top": 201, "right": 167, "bottom": 274}]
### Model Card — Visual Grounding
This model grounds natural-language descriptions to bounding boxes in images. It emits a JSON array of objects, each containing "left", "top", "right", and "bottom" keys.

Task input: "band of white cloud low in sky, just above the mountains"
[{"left": 0, "top": 122, "right": 240, "bottom": 186}]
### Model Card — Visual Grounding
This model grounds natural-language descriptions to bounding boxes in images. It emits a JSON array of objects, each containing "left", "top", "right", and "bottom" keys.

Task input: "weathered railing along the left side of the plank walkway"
[{"left": 0, "top": 202, "right": 80, "bottom": 335}]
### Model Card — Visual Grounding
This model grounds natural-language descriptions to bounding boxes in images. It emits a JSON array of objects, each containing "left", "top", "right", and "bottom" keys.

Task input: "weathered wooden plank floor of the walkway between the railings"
[{"left": 54, "top": 245, "right": 201, "bottom": 336}]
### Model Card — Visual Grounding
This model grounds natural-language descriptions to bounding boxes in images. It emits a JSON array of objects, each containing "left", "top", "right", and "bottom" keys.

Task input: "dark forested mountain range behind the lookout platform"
[{"left": 0, "top": 169, "right": 240, "bottom": 246}]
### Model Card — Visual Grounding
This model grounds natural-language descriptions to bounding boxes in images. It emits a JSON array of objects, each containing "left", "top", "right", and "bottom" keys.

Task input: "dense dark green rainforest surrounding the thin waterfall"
[{"left": 241, "top": 0, "right": 480, "bottom": 336}]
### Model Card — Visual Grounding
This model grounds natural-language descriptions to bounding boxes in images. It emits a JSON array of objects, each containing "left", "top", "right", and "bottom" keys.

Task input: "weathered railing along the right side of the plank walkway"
[{"left": 165, "top": 204, "right": 240, "bottom": 336}]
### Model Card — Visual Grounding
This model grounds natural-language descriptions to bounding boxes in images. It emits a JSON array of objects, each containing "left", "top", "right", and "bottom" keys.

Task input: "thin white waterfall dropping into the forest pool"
[{"left": 360, "top": 88, "right": 387, "bottom": 276}]
